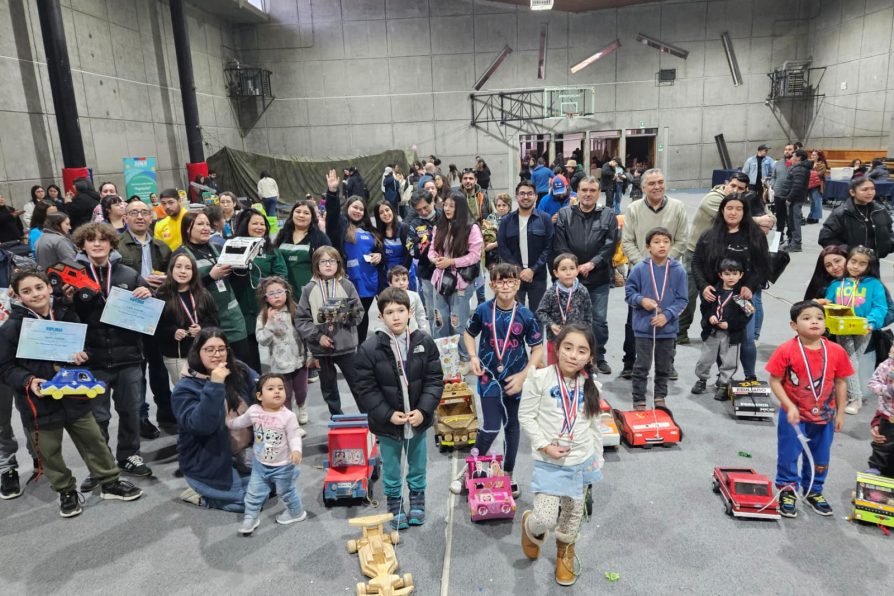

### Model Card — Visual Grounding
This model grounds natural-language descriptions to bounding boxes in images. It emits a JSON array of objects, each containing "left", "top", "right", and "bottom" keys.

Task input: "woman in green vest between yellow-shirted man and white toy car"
[{"left": 171, "top": 211, "right": 251, "bottom": 362}]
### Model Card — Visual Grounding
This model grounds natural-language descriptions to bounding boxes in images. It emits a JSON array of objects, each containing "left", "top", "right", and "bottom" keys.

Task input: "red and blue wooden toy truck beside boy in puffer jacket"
[{"left": 323, "top": 414, "right": 381, "bottom": 507}]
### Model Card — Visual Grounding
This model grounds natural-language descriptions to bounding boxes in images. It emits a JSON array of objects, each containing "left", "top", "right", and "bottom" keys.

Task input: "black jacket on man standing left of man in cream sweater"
[{"left": 550, "top": 205, "right": 620, "bottom": 288}]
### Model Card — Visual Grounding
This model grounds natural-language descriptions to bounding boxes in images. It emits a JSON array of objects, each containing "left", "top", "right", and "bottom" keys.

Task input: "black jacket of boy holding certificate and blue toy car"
[{"left": 0, "top": 301, "right": 92, "bottom": 430}]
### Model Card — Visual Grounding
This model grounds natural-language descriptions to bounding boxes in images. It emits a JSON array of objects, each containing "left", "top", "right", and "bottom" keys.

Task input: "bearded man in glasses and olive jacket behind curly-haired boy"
[{"left": 118, "top": 201, "right": 177, "bottom": 439}]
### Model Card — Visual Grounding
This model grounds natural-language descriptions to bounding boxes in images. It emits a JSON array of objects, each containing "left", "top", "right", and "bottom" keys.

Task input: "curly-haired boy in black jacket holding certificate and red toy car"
[{"left": 74, "top": 222, "right": 152, "bottom": 484}]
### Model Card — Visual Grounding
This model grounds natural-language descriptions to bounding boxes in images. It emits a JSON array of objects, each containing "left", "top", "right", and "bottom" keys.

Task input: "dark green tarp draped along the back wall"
[{"left": 208, "top": 147, "right": 415, "bottom": 205}]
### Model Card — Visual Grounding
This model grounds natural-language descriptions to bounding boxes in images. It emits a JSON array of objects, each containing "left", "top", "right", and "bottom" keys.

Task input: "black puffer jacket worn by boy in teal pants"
[{"left": 354, "top": 330, "right": 444, "bottom": 441}]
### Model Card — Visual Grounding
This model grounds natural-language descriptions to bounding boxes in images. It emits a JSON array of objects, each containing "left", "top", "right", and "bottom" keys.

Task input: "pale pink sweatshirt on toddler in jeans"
[{"left": 227, "top": 404, "right": 301, "bottom": 467}]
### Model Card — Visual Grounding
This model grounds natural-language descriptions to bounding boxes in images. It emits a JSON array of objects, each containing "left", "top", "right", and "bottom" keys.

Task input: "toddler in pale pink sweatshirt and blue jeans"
[{"left": 227, "top": 373, "right": 307, "bottom": 534}]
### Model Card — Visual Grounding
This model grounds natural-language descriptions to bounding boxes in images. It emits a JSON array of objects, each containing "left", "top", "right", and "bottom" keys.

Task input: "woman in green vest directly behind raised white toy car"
[{"left": 230, "top": 209, "right": 286, "bottom": 370}]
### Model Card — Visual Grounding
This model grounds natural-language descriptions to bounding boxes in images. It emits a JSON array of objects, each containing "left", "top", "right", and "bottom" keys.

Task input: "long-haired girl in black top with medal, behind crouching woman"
[{"left": 155, "top": 253, "right": 218, "bottom": 385}]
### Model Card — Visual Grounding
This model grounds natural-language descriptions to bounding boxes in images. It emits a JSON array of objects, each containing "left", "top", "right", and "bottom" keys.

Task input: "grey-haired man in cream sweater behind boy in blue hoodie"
[{"left": 621, "top": 168, "right": 692, "bottom": 380}]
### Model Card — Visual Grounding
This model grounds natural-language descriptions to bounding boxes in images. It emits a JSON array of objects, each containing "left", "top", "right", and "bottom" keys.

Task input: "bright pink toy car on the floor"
[{"left": 466, "top": 449, "right": 516, "bottom": 521}]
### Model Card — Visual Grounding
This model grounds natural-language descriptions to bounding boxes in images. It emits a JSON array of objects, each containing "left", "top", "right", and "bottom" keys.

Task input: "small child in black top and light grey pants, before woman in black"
[{"left": 692, "top": 259, "right": 754, "bottom": 401}]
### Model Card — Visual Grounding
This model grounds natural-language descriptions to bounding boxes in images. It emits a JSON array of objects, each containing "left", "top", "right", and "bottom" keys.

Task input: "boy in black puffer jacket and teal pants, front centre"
[{"left": 355, "top": 287, "right": 444, "bottom": 530}]
